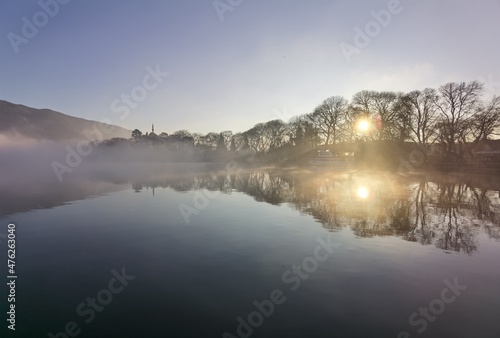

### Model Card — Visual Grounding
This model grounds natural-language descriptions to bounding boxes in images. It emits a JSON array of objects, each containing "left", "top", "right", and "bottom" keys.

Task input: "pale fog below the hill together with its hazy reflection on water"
[{"left": 0, "top": 138, "right": 232, "bottom": 217}]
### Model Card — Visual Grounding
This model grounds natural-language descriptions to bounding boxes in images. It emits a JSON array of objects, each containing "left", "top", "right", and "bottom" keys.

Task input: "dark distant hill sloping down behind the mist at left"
[{"left": 0, "top": 100, "right": 132, "bottom": 141}]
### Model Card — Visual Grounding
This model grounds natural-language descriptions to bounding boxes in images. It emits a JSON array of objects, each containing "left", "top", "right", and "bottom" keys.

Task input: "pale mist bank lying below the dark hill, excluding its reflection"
[{"left": 0, "top": 141, "right": 244, "bottom": 185}]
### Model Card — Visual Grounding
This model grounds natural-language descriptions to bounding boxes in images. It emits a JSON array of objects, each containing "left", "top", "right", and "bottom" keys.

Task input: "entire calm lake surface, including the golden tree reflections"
[{"left": 0, "top": 171, "right": 500, "bottom": 338}]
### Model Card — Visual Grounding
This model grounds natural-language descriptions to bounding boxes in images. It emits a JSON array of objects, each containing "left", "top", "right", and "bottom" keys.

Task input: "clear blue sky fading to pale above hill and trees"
[{"left": 0, "top": 0, "right": 500, "bottom": 133}]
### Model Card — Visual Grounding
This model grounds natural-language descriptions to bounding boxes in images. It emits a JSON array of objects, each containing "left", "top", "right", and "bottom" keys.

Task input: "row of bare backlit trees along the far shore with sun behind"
[{"left": 99, "top": 81, "right": 500, "bottom": 159}]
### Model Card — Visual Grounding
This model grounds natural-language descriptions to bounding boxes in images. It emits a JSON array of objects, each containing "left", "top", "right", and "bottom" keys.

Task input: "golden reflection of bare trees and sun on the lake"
[{"left": 129, "top": 172, "right": 500, "bottom": 254}]
